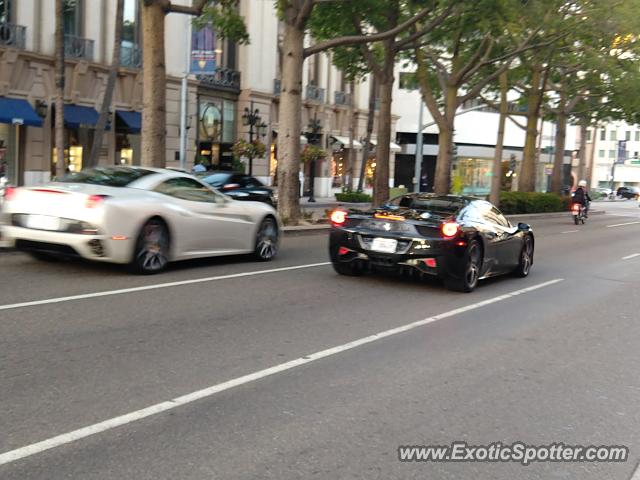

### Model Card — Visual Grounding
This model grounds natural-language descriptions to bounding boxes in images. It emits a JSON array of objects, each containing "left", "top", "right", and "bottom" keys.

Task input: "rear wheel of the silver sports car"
[{"left": 132, "top": 218, "right": 169, "bottom": 275}]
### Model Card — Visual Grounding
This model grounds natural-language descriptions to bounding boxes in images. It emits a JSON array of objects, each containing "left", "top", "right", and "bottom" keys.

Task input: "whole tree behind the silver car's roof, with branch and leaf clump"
[{"left": 141, "top": 0, "right": 249, "bottom": 167}]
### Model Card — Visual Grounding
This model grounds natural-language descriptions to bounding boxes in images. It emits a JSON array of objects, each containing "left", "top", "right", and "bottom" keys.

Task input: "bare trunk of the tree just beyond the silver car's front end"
[{"left": 278, "top": 22, "right": 304, "bottom": 221}]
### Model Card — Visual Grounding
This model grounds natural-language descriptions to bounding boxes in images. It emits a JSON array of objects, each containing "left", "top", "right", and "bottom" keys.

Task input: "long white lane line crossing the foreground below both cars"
[{"left": 0, "top": 278, "right": 564, "bottom": 465}]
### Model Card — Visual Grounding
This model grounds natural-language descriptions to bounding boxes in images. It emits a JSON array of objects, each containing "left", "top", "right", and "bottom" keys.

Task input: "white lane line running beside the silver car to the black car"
[{"left": 0, "top": 262, "right": 331, "bottom": 310}]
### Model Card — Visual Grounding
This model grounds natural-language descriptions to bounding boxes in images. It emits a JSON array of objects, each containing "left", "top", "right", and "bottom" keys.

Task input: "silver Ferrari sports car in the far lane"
[{"left": 2, "top": 166, "right": 280, "bottom": 273}]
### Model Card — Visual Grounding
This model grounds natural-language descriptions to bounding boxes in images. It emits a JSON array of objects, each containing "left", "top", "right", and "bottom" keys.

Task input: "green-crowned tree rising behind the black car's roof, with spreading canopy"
[{"left": 413, "top": 0, "right": 564, "bottom": 193}]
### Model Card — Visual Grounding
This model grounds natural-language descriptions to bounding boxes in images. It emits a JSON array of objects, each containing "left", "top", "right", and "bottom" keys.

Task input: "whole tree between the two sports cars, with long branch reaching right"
[{"left": 277, "top": 0, "right": 442, "bottom": 223}]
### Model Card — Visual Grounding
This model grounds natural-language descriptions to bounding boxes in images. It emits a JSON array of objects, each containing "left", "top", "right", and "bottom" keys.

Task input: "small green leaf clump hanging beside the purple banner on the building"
[{"left": 193, "top": 0, "right": 249, "bottom": 45}]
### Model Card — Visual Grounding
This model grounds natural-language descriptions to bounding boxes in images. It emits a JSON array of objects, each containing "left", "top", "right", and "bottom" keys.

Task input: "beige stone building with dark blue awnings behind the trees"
[{"left": 0, "top": 0, "right": 397, "bottom": 196}]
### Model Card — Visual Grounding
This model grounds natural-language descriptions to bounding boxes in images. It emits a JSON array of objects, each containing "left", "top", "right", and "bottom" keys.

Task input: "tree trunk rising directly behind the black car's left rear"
[{"left": 373, "top": 51, "right": 395, "bottom": 206}]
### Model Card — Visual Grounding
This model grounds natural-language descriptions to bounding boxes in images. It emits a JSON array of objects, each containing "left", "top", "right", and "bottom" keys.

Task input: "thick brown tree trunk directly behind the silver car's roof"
[{"left": 140, "top": 1, "right": 167, "bottom": 167}]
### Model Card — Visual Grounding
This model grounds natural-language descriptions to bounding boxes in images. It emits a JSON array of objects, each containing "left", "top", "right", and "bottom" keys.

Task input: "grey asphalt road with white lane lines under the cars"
[{"left": 0, "top": 202, "right": 640, "bottom": 480}]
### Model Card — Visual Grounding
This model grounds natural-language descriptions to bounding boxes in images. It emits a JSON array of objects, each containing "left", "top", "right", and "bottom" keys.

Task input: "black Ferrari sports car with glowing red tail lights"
[{"left": 329, "top": 193, "right": 534, "bottom": 292}]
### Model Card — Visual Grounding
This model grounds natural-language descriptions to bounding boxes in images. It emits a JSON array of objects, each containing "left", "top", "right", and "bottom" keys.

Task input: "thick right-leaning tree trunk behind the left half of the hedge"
[{"left": 518, "top": 66, "right": 542, "bottom": 192}]
